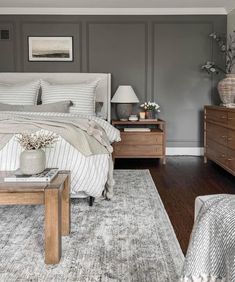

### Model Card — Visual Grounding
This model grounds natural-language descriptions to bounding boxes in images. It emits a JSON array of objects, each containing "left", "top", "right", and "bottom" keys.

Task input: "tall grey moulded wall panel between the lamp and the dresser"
[{"left": 152, "top": 21, "right": 213, "bottom": 146}]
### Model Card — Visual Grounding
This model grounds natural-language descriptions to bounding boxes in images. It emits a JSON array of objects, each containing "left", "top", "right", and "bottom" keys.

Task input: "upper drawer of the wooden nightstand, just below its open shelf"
[{"left": 119, "top": 132, "right": 163, "bottom": 145}]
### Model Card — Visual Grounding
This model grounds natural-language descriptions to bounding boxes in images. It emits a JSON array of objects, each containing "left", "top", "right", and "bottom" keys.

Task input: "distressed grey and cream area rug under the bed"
[{"left": 0, "top": 170, "right": 184, "bottom": 282}]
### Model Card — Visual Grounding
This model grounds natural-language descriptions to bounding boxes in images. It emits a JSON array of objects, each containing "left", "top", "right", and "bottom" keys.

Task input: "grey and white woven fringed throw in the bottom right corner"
[{"left": 180, "top": 195, "right": 235, "bottom": 282}]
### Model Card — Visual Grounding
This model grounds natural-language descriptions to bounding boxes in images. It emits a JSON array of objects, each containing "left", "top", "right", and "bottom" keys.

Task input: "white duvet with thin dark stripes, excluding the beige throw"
[{"left": 0, "top": 112, "right": 120, "bottom": 197}]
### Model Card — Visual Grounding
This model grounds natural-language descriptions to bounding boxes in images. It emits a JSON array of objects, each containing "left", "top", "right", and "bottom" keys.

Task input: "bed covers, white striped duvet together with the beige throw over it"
[{"left": 0, "top": 112, "right": 120, "bottom": 197}]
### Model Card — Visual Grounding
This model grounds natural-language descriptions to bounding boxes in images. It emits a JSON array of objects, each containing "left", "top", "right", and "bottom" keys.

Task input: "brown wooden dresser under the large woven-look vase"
[{"left": 204, "top": 106, "right": 235, "bottom": 175}]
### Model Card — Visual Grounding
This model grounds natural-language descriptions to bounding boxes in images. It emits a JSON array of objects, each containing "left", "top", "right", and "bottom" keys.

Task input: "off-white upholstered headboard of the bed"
[{"left": 0, "top": 72, "right": 111, "bottom": 122}]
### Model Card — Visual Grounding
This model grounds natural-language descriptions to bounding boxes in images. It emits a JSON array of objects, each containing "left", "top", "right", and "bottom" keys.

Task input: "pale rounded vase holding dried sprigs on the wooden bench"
[{"left": 20, "top": 149, "right": 46, "bottom": 175}]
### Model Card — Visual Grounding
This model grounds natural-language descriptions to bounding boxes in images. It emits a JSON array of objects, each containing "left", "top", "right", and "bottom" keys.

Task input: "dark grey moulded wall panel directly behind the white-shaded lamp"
[{"left": 86, "top": 21, "right": 149, "bottom": 100}]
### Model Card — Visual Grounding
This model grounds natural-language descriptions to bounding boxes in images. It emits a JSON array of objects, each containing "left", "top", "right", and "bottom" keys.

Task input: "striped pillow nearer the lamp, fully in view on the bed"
[{"left": 41, "top": 80, "right": 98, "bottom": 115}]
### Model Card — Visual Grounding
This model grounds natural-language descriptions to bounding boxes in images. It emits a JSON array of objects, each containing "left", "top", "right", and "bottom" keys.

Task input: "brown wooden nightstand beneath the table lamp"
[{"left": 112, "top": 119, "right": 166, "bottom": 164}]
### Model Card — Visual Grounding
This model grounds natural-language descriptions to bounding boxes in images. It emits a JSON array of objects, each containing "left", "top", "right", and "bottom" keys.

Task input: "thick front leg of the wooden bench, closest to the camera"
[{"left": 45, "top": 188, "right": 61, "bottom": 264}]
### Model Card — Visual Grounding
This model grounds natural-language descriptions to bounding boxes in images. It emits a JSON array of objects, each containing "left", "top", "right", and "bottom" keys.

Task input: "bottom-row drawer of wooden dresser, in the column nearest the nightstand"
[{"left": 206, "top": 139, "right": 227, "bottom": 165}]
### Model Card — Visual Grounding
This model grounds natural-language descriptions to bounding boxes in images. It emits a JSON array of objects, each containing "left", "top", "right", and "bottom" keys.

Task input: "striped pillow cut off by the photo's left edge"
[{"left": 0, "top": 80, "right": 40, "bottom": 105}]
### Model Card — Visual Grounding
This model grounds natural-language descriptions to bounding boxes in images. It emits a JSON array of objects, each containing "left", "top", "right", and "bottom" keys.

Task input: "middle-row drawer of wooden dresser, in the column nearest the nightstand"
[{"left": 206, "top": 122, "right": 228, "bottom": 145}]
